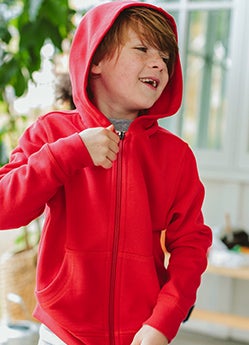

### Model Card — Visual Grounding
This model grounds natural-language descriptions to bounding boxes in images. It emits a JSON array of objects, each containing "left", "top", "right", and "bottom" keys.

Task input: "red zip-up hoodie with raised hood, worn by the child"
[{"left": 0, "top": 1, "right": 211, "bottom": 345}]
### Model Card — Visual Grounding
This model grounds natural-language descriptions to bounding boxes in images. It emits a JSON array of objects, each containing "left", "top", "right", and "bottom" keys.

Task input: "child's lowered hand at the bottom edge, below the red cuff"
[{"left": 131, "top": 325, "right": 168, "bottom": 345}]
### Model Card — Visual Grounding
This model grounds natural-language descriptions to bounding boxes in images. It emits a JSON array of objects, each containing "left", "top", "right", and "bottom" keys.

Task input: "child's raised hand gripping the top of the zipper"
[{"left": 80, "top": 125, "right": 120, "bottom": 169}]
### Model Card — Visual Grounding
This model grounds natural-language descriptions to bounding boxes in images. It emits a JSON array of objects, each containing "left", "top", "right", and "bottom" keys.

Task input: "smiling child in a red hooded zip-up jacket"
[{"left": 0, "top": 1, "right": 211, "bottom": 345}]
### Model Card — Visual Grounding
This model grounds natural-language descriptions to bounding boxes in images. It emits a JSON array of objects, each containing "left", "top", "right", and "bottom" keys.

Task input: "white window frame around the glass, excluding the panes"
[{"left": 154, "top": 0, "right": 249, "bottom": 182}]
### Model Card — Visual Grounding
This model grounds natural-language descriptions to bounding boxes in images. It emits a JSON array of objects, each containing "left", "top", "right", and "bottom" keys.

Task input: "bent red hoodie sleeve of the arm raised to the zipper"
[{"left": 0, "top": 114, "right": 93, "bottom": 230}]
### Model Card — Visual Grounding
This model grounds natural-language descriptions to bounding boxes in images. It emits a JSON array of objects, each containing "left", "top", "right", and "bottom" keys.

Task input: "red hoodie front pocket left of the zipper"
[{"left": 36, "top": 251, "right": 110, "bottom": 334}]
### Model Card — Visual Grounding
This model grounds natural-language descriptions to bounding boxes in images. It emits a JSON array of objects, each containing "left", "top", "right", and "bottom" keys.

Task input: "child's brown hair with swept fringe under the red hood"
[{"left": 93, "top": 6, "right": 178, "bottom": 75}]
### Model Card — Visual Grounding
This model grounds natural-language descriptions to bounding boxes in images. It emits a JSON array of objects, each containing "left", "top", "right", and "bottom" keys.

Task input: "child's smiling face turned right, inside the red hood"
[{"left": 91, "top": 29, "right": 169, "bottom": 119}]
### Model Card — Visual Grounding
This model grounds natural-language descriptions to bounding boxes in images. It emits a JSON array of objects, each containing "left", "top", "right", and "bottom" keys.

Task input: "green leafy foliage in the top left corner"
[{"left": 0, "top": 0, "right": 75, "bottom": 102}]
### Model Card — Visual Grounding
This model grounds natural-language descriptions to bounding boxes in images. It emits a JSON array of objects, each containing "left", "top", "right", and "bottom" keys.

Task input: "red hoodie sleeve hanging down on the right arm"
[{"left": 145, "top": 145, "right": 212, "bottom": 341}]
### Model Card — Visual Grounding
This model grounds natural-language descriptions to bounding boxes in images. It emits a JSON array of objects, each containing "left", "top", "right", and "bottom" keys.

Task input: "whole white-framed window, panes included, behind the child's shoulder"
[{"left": 154, "top": 0, "right": 249, "bottom": 180}]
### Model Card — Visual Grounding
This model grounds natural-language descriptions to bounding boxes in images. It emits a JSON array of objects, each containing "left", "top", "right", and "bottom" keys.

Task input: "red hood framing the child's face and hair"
[{"left": 69, "top": 0, "right": 182, "bottom": 127}]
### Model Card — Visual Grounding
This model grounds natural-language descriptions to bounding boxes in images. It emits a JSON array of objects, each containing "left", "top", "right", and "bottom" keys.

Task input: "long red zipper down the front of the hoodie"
[{"left": 109, "top": 131, "right": 125, "bottom": 345}]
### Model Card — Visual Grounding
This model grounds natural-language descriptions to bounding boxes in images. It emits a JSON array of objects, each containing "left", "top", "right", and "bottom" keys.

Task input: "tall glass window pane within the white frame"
[{"left": 181, "top": 9, "right": 231, "bottom": 149}]
